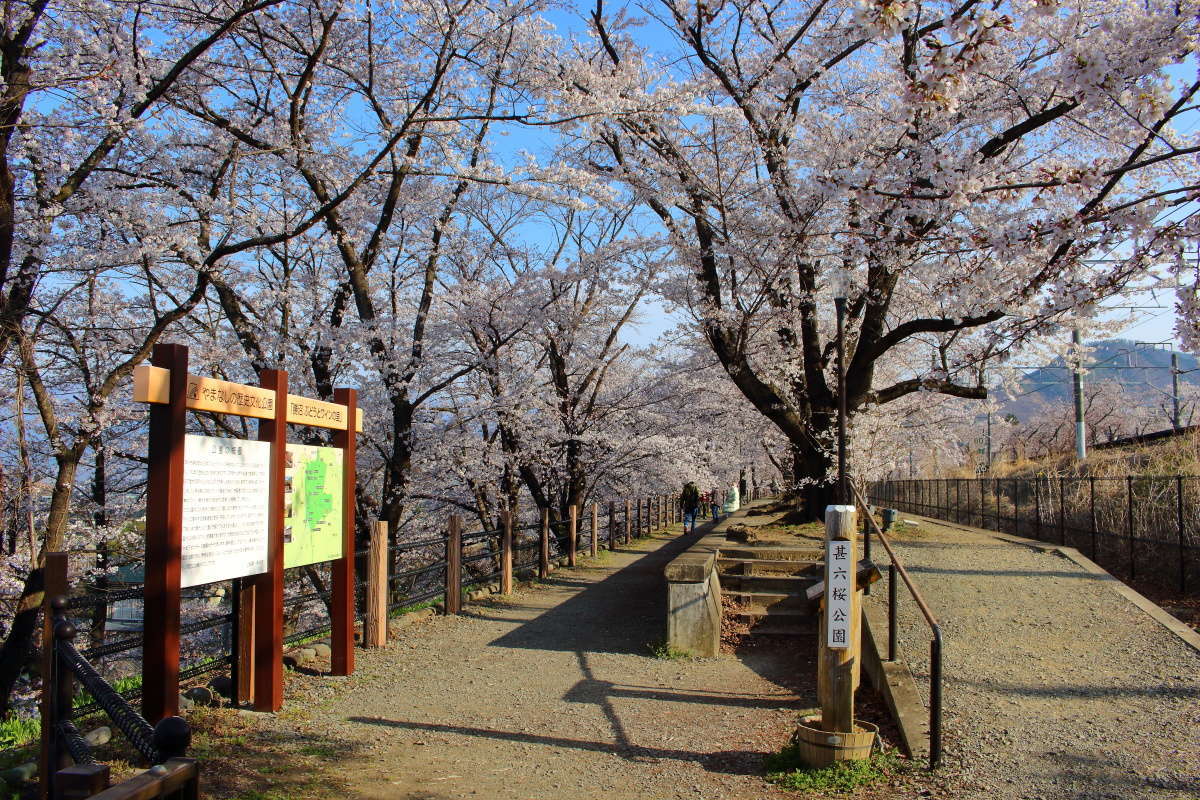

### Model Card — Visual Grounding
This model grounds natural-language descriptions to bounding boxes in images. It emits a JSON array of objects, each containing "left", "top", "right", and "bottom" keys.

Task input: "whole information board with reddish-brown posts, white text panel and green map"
[{"left": 133, "top": 344, "right": 362, "bottom": 722}]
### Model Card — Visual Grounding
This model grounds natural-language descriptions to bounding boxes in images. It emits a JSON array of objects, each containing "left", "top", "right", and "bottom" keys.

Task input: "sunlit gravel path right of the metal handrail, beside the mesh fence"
[{"left": 883, "top": 515, "right": 1200, "bottom": 800}]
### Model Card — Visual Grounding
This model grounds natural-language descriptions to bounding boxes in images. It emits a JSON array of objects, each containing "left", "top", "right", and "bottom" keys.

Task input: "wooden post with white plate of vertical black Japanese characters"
[{"left": 817, "top": 505, "right": 862, "bottom": 732}]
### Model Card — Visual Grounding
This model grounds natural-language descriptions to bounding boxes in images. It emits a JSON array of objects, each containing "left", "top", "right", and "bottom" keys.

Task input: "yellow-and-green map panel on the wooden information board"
[{"left": 283, "top": 444, "right": 342, "bottom": 569}]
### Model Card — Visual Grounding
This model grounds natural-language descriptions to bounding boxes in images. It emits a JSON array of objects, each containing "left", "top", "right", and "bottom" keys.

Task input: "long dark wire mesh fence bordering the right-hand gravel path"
[{"left": 869, "top": 475, "right": 1200, "bottom": 594}]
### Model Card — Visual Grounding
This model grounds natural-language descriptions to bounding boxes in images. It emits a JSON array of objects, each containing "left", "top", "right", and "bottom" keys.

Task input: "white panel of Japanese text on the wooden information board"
[{"left": 180, "top": 435, "right": 271, "bottom": 587}]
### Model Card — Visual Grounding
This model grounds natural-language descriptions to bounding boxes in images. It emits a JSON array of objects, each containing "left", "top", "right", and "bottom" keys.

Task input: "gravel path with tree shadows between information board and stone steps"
[{"left": 266, "top": 530, "right": 814, "bottom": 800}]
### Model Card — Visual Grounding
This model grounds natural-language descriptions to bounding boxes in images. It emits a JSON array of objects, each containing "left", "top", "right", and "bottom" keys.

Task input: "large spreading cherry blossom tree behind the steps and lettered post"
[{"left": 559, "top": 0, "right": 1200, "bottom": 509}]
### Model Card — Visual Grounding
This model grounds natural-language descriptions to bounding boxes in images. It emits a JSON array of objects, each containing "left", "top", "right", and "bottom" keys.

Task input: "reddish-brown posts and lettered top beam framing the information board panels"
[{"left": 133, "top": 344, "right": 362, "bottom": 722}]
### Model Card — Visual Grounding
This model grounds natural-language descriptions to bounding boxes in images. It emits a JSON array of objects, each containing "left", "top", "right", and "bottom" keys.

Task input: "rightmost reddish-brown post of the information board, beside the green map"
[{"left": 328, "top": 389, "right": 359, "bottom": 676}]
